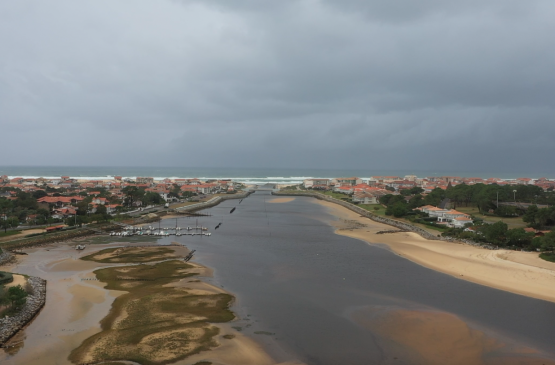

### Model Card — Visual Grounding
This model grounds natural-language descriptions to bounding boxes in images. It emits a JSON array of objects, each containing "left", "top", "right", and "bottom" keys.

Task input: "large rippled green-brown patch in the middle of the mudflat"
[{"left": 69, "top": 256, "right": 235, "bottom": 365}]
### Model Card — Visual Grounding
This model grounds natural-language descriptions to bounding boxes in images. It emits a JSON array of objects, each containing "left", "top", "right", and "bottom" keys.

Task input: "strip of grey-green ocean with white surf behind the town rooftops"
[{"left": 0, "top": 166, "right": 552, "bottom": 184}]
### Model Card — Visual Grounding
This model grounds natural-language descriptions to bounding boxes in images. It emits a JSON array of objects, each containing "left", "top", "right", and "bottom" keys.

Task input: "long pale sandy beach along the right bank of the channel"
[{"left": 316, "top": 200, "right": 555, "bottom": 302}]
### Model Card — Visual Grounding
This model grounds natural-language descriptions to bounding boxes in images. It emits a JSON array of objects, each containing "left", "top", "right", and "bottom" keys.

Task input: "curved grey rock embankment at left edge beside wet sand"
[{"left": 0, "top": 276, "right": 46, "bottom": 347}]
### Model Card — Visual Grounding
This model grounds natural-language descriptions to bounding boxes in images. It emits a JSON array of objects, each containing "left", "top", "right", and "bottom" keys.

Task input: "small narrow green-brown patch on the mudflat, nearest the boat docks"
[{"left": 81, "top": 247, "right": 178, "bottom": 264}]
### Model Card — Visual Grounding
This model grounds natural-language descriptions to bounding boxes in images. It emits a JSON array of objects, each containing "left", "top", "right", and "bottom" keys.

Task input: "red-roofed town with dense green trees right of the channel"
[{"left": 300, "top": 175, "right": 555, "bottom": 255}]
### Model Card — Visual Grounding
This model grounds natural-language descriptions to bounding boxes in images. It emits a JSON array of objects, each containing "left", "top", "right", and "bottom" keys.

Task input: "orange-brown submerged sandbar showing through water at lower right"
[{"left": 349, "top": 306, "right": 555, "bottom": 365}]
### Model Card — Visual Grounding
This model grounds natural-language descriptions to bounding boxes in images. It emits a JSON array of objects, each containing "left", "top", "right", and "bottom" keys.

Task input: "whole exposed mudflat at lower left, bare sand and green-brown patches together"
[{"left": 0, "top": 242, "right": 282, "bottom": 365}]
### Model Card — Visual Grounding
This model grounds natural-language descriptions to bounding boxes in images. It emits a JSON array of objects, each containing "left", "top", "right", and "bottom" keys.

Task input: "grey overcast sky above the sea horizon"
[{"left": 0, "top": 0, "right": 555, "bottom": 171}]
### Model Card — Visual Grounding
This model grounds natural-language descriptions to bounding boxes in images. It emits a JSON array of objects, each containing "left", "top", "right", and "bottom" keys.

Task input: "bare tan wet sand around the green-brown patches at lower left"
[{"left": 0, "top": 242, "right": 286, "bottom": 365}]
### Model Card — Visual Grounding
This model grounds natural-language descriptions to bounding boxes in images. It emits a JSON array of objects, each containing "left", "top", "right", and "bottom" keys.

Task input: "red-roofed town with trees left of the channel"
[{"left": 0, "top": 175, "right": 243, "bottom": 229}]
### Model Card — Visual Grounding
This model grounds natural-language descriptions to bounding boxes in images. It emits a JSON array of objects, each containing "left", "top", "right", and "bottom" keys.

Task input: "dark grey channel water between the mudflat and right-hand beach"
[{"left": 163, "top": 191, "right": 555, "bottom": 364}]
